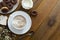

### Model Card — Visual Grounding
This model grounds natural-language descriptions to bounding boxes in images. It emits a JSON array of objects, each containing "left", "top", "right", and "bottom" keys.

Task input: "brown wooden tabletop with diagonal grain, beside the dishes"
[{"left": 0, "top": 0, "right": 60, "bottom": 40}]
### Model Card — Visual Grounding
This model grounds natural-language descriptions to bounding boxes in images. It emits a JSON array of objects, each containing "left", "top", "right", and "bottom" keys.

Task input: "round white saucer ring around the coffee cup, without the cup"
[{"left": 8, "top": 11, "right": 32, "bottom": 34}]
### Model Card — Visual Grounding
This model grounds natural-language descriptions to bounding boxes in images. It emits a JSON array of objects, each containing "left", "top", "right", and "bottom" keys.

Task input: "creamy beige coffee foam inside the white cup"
[{"left": 12, "top": 16, "right": 26, "bottom": 28}]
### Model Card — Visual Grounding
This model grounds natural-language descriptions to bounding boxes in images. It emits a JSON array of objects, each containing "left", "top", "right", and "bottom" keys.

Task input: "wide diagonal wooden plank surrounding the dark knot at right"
[{"left": 33, "top": 0, "right": 60, "bottom": 40}]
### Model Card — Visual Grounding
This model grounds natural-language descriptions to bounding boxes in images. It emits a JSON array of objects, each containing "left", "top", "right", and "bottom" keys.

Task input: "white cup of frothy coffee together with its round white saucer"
[{"left": 8, "top": 11, "right": 32, "bottom": 34}]
